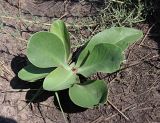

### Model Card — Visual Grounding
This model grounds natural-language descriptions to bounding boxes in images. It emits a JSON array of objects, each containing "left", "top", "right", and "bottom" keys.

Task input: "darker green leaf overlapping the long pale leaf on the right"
[{"left": 78, "top": 43, "right": 124, "bottom": 77}]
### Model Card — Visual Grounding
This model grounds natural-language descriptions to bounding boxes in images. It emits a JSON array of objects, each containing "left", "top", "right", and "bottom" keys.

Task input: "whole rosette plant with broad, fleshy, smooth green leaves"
[{"left": 18, "top": 20, "right": 143, "bottom": 108}]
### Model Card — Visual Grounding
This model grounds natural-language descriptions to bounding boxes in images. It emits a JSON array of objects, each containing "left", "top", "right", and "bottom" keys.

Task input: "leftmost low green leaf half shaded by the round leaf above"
[{"left": 18, "top": 64, "right": 54, "bottom": 82}]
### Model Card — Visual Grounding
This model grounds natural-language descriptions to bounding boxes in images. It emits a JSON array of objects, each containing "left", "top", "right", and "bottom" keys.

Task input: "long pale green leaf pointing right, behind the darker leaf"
[{"left": 86, "top": 27, "right": 143, "bottom": 51}]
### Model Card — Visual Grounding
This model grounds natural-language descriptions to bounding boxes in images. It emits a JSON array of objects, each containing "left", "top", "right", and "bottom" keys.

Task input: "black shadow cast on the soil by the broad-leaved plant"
[{"left": 10, "top": 55, "right": 86, "bottom": 113}]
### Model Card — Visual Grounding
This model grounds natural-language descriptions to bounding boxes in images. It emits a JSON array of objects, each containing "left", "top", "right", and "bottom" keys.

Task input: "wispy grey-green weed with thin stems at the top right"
[{"left": 90, "top": 0, "right": 146, "bottom": 29}]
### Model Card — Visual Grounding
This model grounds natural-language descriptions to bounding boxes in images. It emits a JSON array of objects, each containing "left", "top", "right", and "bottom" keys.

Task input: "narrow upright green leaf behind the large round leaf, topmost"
[{"left": 50, "top": 20, "right": 71, "bottom": 59}]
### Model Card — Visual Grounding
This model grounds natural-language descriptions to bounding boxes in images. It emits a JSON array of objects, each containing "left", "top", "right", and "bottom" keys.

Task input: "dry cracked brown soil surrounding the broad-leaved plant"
[{"left": 0, "top": 0, "right": 160, "bottom": 123}]
